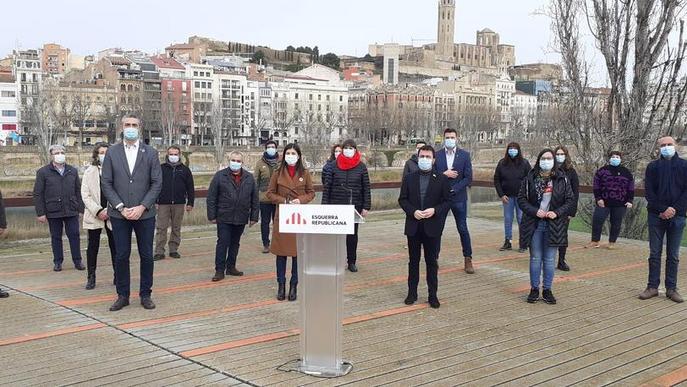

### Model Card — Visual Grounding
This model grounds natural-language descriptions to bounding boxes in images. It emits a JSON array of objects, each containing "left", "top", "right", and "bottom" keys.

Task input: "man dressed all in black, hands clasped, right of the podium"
[{"left": 398, "top": 145, "right": 451, "bottom": 308}]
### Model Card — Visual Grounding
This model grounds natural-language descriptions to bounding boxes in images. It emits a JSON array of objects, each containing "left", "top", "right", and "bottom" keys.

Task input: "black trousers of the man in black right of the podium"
[{"left": 408, "top": 223, "right": 441, "bottom": 297}]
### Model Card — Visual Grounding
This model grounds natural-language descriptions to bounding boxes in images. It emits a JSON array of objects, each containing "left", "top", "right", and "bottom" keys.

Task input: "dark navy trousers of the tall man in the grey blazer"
[{"left": 110, "top": 217, "right": 155, "bottom": 297}]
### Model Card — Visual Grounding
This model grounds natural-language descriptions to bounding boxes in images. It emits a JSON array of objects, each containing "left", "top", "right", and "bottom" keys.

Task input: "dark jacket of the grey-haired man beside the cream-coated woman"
[{"left": 33, "top": 163, "right": 85, "bottom": 218}]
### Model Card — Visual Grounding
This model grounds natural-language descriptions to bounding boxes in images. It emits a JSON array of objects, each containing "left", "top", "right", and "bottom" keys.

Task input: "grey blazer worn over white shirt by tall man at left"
[{"left": 100, "top": 141, "right": 162, "bottom": 219}]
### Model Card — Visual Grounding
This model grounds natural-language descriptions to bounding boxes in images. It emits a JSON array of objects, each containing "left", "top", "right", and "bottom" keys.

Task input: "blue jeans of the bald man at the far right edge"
[{"left": 647, "top": 212, "right": 685, "bottom": 290}]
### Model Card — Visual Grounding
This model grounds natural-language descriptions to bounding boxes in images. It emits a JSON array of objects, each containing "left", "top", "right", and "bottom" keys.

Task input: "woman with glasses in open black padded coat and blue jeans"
[{"left": 518, "top": 149, "right": 577, "bottom": 304}]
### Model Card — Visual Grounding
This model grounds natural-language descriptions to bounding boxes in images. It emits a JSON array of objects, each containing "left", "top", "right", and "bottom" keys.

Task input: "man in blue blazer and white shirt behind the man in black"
[{"left": 436, "top": 128, "right": 475, "bottom": 274}]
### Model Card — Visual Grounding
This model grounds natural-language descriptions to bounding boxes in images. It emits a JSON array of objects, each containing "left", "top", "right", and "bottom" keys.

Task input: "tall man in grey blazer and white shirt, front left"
[{"left": 101, "top": 116, "right": 162, "bottom": 311}]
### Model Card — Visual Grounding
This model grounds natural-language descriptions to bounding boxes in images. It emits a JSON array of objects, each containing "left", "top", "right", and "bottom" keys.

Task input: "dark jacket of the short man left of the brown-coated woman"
[{"left": 207, "top": 168, "right": 259, "bottom": 225}]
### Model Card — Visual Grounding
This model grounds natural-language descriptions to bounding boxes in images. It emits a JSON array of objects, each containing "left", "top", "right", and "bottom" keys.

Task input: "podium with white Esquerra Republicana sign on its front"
[{"left": 279, "top": 204, "right": 364, "bottom": 377}]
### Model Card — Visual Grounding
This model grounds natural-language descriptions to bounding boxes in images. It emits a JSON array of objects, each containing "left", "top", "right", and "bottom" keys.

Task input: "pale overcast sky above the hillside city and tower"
[{"left": 0, "top": 0, "right": 558, "bottom": 64}]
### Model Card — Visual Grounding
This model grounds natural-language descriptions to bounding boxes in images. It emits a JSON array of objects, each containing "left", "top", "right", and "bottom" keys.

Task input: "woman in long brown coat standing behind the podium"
[{"left": 267, "top": 144, "right": 315, "bottom": 301}]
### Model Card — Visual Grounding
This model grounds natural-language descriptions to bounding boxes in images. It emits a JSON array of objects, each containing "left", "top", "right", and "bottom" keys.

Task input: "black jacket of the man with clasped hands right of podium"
[{"left": 398, "top": 171, "right": 451, "bottom": 238}]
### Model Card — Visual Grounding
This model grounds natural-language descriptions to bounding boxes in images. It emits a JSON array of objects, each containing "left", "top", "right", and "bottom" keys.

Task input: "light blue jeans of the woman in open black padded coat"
[{"left": 530, "top": 220, "right": 558, "bottom": 289}]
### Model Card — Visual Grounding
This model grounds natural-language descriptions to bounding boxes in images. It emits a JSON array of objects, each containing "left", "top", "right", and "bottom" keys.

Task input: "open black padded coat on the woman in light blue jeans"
[{"left": 518, "top": 169, "right": 577, "bottom": 248}]
